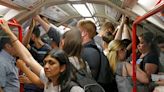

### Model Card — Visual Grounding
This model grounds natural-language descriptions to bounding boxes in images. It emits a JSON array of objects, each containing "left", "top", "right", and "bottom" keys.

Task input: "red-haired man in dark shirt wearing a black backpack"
[{"left": 77, "top": 20, "right": 112, "bottom": 92}]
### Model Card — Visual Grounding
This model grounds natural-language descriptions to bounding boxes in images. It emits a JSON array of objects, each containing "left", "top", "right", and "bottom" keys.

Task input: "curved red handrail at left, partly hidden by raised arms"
[{"left": 0, "top": 19, "right": 24, "bottom": 92}]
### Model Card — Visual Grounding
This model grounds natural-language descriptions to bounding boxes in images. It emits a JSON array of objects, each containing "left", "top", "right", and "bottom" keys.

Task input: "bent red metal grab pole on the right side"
[{"left": 132, "top": 3, "right": 164, "bottom": 92}]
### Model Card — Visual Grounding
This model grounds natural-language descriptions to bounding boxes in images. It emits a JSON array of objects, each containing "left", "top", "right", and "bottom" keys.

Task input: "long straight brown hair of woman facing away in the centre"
[{"left": 62, "top": 30, "right": 85, "bottom": 68}]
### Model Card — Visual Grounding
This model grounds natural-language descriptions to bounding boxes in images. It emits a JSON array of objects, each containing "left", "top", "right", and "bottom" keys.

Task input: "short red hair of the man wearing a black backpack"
[{"left": 77, "top": 19, "right": 96, "bottom": 38}]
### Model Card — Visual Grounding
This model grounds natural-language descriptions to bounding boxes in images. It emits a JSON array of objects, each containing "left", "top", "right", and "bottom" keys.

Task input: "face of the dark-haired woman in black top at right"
[{"left": 137, "top": 37, "right": 148, "bottom": 53}]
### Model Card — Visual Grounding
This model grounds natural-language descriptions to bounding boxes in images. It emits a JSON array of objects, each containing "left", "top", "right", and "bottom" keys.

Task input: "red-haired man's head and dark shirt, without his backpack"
[{"left": 77, "top": 20, "right": 100, "bottom": 80}]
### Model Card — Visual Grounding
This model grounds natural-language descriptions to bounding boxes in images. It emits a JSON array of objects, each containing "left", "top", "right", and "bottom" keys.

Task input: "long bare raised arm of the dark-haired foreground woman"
[{"left": 0, "top": 20, "right": 43, "bottom": 76}]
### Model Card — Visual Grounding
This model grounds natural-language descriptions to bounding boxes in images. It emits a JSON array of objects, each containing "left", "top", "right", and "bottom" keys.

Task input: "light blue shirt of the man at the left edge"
[{"left": 0, "top": 50, "right": 20, "bottom": 92}]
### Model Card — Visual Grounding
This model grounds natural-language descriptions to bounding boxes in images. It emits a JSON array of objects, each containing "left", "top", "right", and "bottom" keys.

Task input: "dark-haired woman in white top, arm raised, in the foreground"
[{"left": 0, "top": 20, "right": 84, "bottom": 92}]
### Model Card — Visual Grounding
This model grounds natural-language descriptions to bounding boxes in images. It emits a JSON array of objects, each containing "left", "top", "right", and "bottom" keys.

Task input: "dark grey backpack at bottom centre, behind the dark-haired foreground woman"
[{"left": 62, "top": 65, "right": 105, "bottom": 92}]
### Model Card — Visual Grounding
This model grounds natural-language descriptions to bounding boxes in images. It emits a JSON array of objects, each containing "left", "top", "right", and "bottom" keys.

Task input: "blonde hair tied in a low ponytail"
[{"left": 107, "top": 40, "right": 124, "bottom": 73}]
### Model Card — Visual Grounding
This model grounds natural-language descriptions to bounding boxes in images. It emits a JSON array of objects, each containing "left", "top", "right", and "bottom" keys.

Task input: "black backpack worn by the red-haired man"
[{"left": 86, "top": 44, "right": 118, "bottom": 92}]
